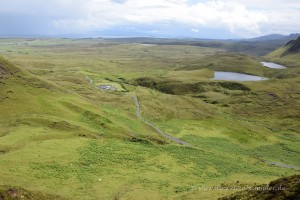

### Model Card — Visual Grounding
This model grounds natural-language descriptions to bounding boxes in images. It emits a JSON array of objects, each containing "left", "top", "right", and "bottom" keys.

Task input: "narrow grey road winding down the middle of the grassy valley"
[{"left": 132, "top": 96, "right": 192, "bottom": 147}]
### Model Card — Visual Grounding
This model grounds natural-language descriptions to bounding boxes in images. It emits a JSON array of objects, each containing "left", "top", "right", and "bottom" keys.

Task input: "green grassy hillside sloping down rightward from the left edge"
[{"left": 0, "top": 55, "right": 158, "bottom": 141}]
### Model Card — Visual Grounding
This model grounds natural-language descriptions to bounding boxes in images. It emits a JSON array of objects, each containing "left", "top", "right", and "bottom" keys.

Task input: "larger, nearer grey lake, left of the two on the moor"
[{"left": 211, "top": 71, "right": 268, "bottom": 81}]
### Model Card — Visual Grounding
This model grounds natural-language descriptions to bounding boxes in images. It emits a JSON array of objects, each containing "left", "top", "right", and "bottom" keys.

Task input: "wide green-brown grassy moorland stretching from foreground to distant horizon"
[{"left": 0, "top": 39, "right": 300, "bottom": 199}]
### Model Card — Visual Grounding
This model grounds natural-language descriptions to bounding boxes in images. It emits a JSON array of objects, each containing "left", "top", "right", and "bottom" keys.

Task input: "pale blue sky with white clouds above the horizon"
[{"left": 0, "top": 0, "right": 300, "bottom": 39}]
